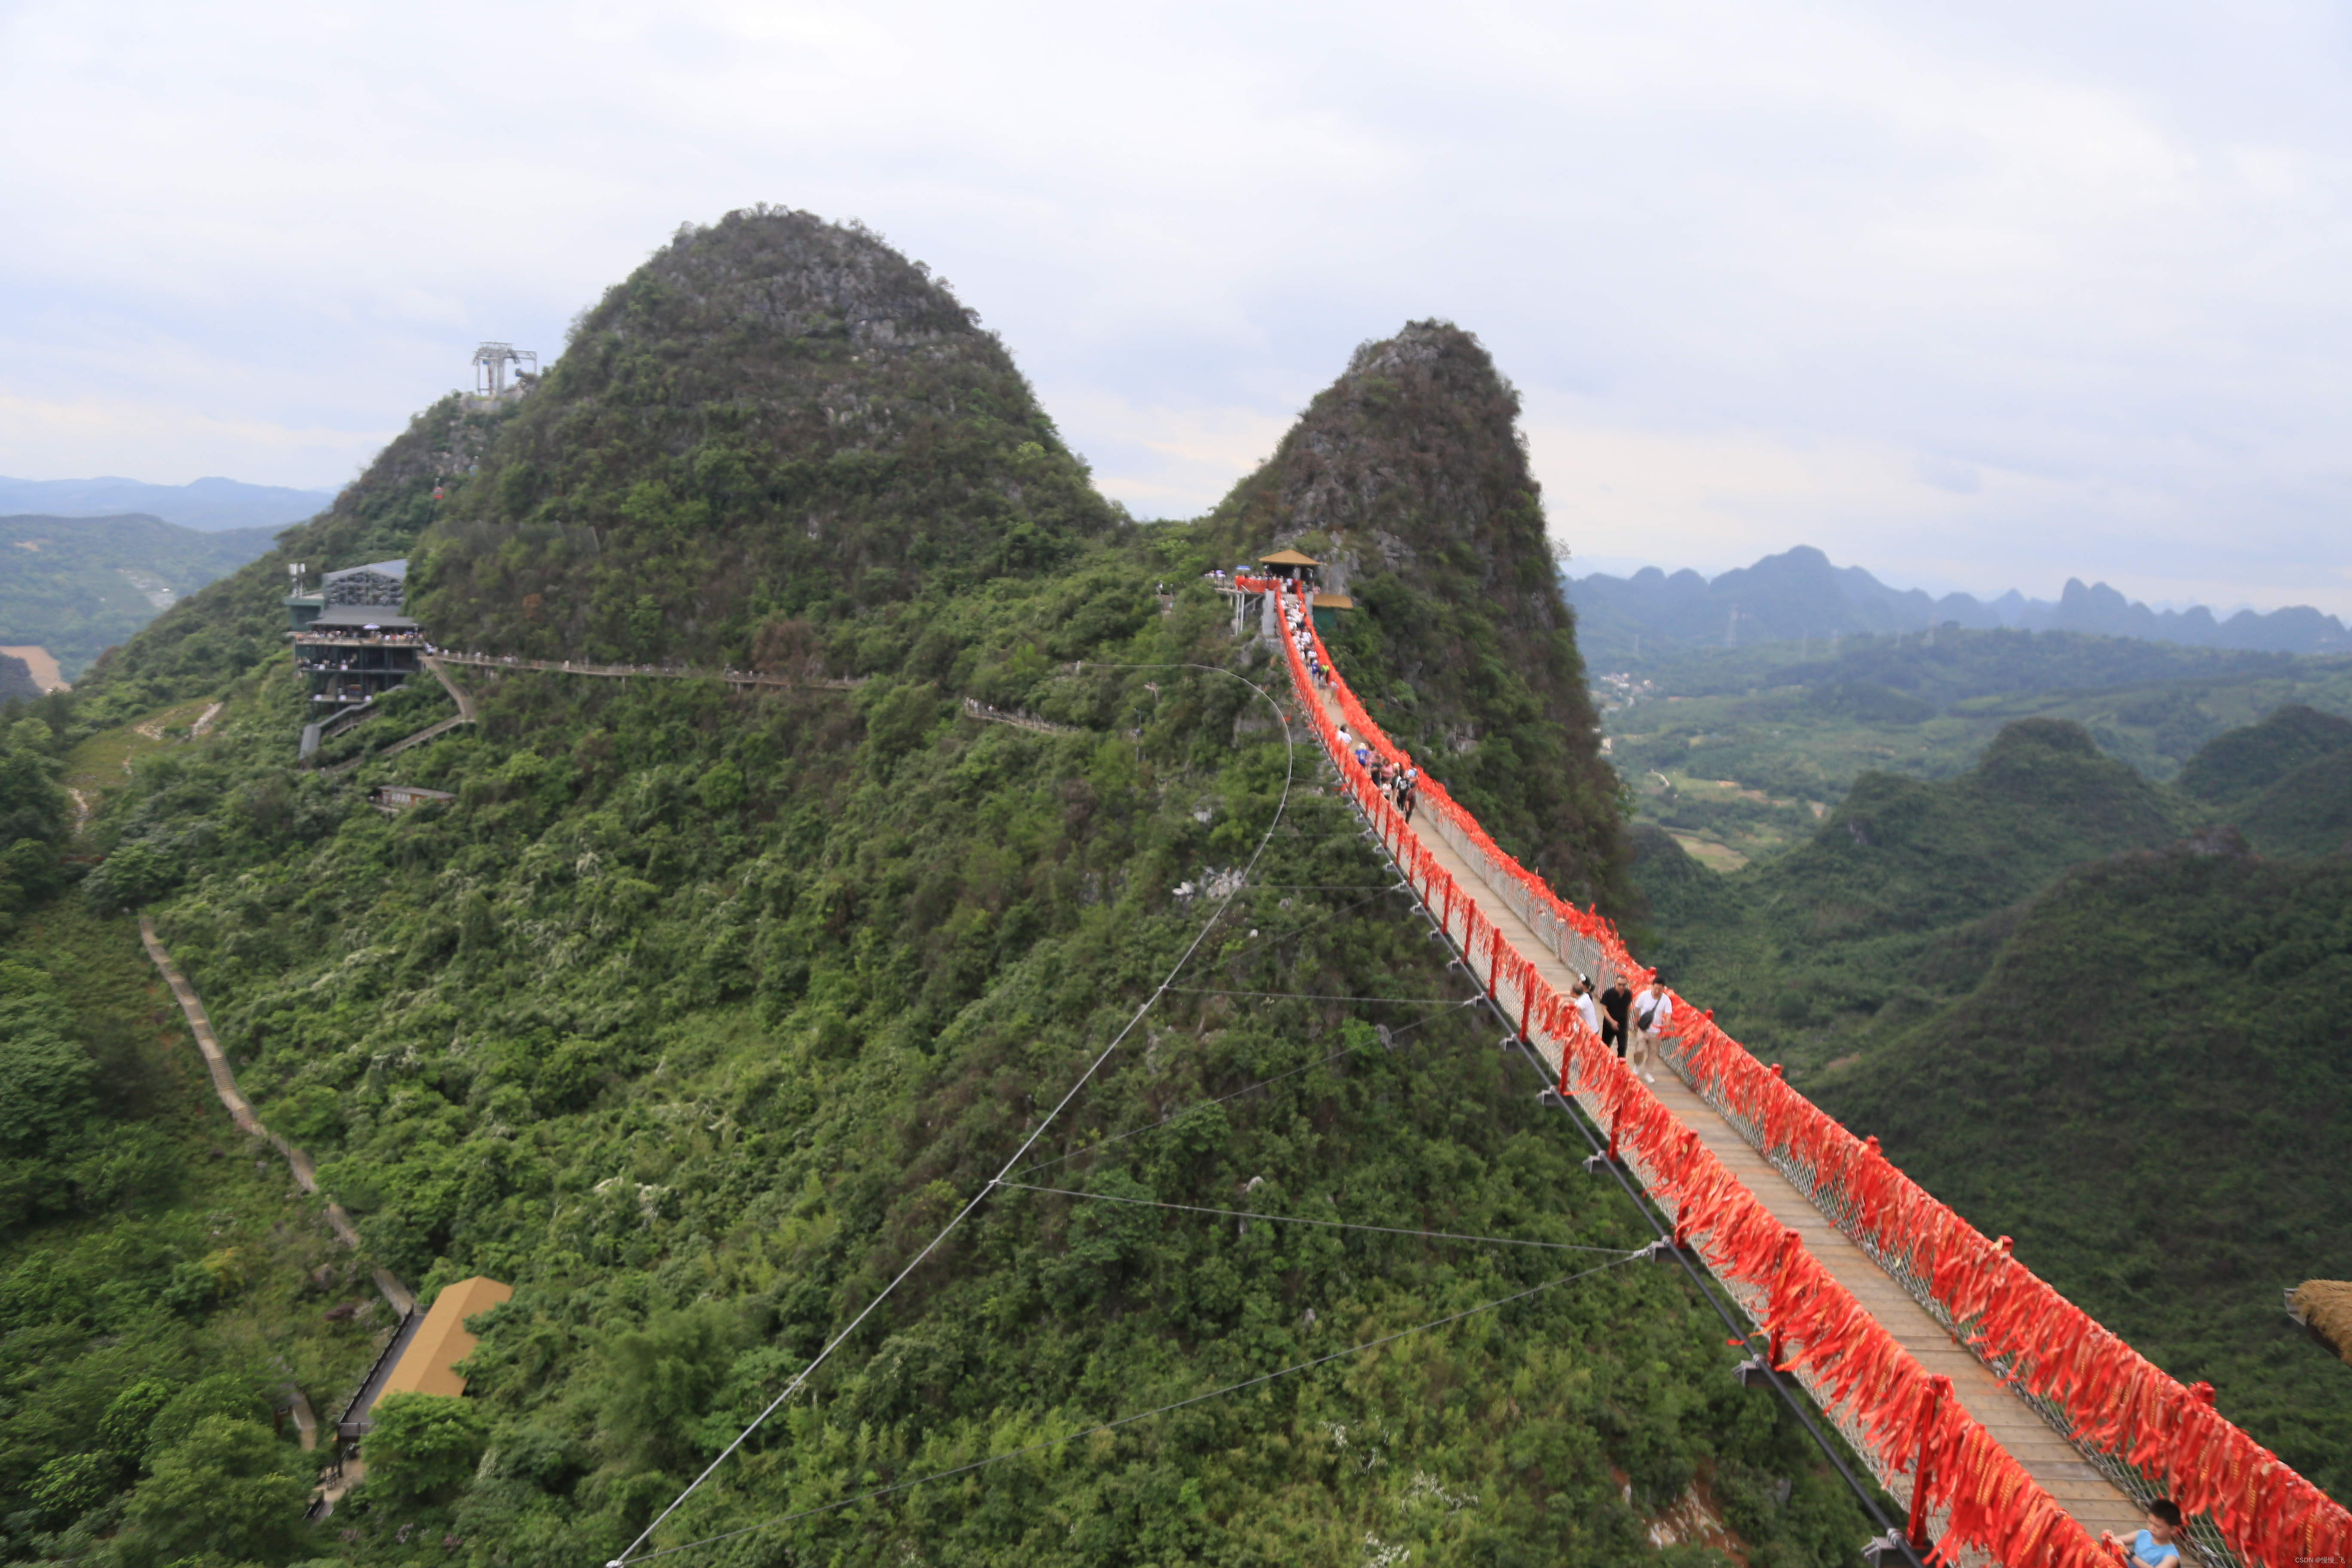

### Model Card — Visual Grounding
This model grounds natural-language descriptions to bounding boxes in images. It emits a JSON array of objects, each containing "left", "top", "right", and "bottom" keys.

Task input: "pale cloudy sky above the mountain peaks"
[{"left": 0, "top": 0, "right": 2352, "bottom": 613}]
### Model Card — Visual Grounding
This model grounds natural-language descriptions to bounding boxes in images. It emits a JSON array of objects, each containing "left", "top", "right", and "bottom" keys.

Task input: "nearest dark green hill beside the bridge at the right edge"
[{"left": 1818, "top": 848, "right": 2352, "bottom": 1498}]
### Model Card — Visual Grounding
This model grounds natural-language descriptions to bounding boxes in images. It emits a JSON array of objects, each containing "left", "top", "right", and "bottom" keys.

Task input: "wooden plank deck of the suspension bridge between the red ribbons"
[{"left": 1317, "top": 693, "right": 2141, "bottom": 1537}]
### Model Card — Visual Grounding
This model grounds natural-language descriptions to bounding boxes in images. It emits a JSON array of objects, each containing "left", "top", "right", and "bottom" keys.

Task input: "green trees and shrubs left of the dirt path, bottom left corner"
[{"left": 0, "top": 893, "right": 383, "bottom": 1563}]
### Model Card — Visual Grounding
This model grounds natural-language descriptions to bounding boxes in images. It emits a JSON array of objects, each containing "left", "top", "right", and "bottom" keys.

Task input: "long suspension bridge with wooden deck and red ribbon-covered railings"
[{"left": 1242, "top": 578, "right": 2352, "bottom": 1568}]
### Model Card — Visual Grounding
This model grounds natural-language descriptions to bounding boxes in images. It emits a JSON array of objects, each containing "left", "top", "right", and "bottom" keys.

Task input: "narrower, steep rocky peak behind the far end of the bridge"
[{"left": 1211, "top": 322, "right": 1632, "bottom": 910}]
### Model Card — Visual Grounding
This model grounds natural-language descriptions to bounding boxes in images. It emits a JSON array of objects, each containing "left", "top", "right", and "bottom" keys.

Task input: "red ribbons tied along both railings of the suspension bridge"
[{"left": 1237, "top": 578, "right": 2352, "bottom": 1568}]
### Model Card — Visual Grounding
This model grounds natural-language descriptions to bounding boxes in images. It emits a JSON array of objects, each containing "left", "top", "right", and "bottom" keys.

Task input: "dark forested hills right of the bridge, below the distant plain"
[{"left": 1637, "top": 705, "right": 2352, "bottom": 1495}]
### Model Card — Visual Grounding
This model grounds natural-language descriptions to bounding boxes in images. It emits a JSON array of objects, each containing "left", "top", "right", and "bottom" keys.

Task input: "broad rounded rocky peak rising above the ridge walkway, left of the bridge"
[{"left": 421, "top": 207, "right": 1115, "bottom": 661}]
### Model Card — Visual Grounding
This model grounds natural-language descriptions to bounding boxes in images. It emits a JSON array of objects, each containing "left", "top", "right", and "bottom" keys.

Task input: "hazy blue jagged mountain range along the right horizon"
[{"left": 1562, "top": 545, "right": 2352, "bottom": 656}]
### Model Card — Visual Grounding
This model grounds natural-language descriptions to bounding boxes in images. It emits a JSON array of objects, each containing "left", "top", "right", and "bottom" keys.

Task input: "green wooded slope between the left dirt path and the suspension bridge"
[{"left": 0, "top": 557, "right": 1860, "bottom": 1563}]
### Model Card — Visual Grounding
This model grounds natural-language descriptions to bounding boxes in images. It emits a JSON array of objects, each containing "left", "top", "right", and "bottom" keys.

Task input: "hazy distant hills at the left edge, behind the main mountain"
[{"left": 0, "top": 515, "right": 275, "bottom": 677}]
